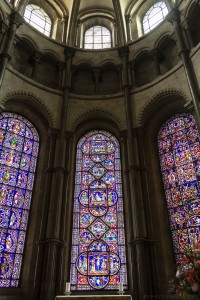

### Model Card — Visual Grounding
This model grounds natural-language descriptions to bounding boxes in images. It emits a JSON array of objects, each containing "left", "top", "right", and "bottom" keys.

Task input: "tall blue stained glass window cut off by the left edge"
[{"left": 0, "top": 113, "right": 39, "bottom": 287}]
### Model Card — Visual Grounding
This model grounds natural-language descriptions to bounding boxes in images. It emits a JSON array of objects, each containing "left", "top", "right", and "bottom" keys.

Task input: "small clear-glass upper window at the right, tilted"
[{"left": 142, "top": 1, "right": 168, "bottom": 33}]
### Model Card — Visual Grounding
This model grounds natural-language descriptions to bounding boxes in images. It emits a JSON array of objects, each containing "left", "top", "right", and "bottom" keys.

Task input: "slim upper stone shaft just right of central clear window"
[{"left": 112, "top": 0, "right": 126, "bottom": 46}]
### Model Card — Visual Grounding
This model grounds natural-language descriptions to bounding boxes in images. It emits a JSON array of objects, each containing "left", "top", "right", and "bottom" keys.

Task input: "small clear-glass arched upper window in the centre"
[{"left": 84, "top": 26, "right": 111, "bottom": 49}]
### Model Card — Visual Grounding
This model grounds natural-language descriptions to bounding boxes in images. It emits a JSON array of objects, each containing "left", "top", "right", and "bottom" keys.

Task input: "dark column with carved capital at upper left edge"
[{"left": 0, "top": 11, "right": 24, "bottom": 89}]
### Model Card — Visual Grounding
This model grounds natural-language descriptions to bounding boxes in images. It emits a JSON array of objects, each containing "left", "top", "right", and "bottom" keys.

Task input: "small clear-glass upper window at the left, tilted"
[{"left": 24, "top": 4, "right": 51, "bottom": 36}]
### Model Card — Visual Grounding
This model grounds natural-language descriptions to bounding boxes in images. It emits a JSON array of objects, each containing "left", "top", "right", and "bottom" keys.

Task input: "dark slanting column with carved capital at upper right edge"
[{"left": 168, "top": 8, "right": 200, "bottom": 133}]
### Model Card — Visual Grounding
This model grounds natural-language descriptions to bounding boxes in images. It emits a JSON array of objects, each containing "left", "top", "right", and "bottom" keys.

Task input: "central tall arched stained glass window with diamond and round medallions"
[{"left": 70, "top": 130, "right": 127, "bottom": 290}]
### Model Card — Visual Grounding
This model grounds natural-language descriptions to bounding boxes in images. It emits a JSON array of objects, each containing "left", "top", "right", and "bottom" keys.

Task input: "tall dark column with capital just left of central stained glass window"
[{"left": 42, "top": 47, "right": 75, "bottom": 300}]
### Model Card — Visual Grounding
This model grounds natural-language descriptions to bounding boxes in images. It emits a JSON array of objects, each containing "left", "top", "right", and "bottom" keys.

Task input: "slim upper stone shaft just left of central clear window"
[{"left": 68, "top": 0, "right": 81, "bottom": 47}]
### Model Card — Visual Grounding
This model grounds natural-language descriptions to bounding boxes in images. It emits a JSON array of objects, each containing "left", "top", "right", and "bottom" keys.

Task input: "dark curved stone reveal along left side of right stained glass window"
[{"left": 140, "top": 92, "right": 190, "bottom": 290}]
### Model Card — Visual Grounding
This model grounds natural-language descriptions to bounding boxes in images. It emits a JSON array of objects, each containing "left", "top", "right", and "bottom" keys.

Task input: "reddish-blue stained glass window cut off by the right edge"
[{"left": 158, "top": 114, "right": 200, "bottom": 260}]
